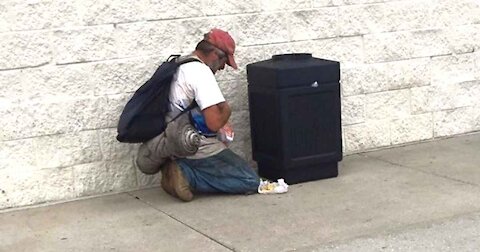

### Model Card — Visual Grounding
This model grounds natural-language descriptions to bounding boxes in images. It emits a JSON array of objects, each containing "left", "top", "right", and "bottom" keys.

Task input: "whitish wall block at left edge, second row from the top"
[{"left": 0, "top": 31, "right": 52, "bottom": 69}]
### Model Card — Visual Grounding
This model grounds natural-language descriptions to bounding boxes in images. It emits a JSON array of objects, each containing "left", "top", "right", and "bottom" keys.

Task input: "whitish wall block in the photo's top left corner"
[{"left": 0, "top": 0, "right": 81, "bottom": 32}]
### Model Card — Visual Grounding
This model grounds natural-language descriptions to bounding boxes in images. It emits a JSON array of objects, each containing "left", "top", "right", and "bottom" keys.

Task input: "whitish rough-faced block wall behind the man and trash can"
[{"left": 0, "top": 0, "right": 480, "bottom": 209}]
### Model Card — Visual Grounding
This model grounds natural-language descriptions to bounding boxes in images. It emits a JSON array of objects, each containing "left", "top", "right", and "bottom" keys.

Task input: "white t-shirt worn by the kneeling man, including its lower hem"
[{"left": 167, "top": 58, "right": 226, "bottom": 159}]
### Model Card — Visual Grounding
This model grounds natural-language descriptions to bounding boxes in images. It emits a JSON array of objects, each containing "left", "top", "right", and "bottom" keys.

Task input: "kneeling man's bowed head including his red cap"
[{"left": 195, "top": 29, "right": 238, "bottom": 73}]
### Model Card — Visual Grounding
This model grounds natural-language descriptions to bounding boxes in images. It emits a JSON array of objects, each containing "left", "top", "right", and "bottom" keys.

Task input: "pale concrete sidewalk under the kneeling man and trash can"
[{"left": 0, "top": 133, "right": 480, "bottom": 251}]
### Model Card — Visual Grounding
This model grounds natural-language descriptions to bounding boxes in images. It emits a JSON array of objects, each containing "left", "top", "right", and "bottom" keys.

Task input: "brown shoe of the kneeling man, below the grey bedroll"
[{"left": 160, "top": 161, "right": 193, "bottom": 202}]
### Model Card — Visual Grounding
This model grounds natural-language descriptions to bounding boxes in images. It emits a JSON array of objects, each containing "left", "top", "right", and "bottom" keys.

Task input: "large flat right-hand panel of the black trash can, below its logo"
[{"left": 279, "top": 83, "right": 342, "bottom": 167}]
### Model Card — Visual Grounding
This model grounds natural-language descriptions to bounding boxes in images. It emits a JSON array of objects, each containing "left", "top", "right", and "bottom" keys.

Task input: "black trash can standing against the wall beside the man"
[{"left": 247, "top": 53, "right": 342, "bottom": 184}]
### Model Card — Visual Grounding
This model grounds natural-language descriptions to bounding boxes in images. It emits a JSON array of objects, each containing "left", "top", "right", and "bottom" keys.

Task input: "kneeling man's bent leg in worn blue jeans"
[{"left": 177, "top": 149, "right": 260, "bottom": 193}]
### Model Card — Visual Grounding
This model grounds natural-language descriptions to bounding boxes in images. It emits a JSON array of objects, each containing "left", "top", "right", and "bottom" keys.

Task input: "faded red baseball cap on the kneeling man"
[{"left": 205, "top": 28, "right": 238, "bottom": 69}]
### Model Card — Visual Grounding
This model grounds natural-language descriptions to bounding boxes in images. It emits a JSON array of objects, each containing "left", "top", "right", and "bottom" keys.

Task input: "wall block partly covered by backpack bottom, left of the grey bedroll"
[{"left": 98, "top": 128, "right": 138, "bottom": 160}]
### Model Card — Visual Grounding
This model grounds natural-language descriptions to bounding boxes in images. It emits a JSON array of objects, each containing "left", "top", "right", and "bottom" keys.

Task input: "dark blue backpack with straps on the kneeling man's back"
[{"left": 117, "top": 55, "right": 199, "bottom": 143}]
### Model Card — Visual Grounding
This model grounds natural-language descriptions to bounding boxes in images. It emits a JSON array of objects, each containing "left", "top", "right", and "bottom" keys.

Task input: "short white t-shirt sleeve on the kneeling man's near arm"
[{"left": 185, "top": 63, "right": 225, "bottom": 110}]
